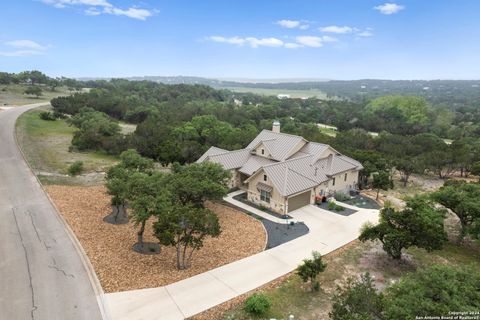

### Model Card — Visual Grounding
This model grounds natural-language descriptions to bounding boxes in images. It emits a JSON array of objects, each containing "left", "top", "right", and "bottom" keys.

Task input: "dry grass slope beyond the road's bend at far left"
[{"left": 0, "top": 84, "right": 70, "bottom": 106}]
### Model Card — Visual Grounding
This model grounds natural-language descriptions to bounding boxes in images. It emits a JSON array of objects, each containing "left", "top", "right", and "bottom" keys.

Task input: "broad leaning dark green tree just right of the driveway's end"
[{"left": 359, "top": 196, "right": 447, "bottom": 259}]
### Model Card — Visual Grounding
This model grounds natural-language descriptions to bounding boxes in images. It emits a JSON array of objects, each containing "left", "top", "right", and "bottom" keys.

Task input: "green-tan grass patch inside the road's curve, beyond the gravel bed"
[{"left": 16, "top": 108, "right": 117, "bottom": 184}]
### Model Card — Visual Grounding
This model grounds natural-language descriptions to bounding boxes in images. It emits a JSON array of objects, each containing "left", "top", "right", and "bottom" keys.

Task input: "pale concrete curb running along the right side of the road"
[{"left": 13, "top": 103, "right": 111, "bottom": 320}]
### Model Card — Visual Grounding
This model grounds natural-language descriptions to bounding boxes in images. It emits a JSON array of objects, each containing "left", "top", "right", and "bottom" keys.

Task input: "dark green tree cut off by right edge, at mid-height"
[{"left": 432, "top": 181, "right": 480, "bottom": 239}]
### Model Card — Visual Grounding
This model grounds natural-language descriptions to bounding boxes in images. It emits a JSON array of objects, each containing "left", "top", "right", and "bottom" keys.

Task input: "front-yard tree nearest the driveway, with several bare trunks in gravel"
[{"left": 153, "top": 204, "right": 221, "bottom": 270}]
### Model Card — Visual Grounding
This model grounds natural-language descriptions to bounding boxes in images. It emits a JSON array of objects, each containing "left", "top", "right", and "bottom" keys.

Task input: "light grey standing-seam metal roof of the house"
[{"left": 197, "top": 130, "right": 363, "bottom": 197}]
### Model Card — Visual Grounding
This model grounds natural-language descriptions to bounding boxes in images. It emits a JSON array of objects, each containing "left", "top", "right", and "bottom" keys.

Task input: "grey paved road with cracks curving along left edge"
[{"left": 0, "top": 105, "right": 102, "bottom": 320}]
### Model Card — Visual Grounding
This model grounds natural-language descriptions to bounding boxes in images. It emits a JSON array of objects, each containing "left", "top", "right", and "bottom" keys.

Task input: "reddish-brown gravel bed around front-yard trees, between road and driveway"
[{"left": 46, "top": 185, "right": 266, "bottom": 292}]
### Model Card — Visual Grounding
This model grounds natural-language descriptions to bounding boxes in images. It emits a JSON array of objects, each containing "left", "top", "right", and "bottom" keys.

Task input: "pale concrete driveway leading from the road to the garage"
[{"left": 106, "top": 201, "right": 378, "bottom": 320}]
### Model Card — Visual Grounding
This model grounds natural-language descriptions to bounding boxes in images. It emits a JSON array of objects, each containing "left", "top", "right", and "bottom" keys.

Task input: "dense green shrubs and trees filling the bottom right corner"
[{"left": 330, "top": 265, "right": 480, "bottom": 320}]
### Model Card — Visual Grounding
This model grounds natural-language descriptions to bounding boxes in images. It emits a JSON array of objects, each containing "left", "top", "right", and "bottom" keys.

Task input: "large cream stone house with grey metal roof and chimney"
[{"left": 197, "top": 121, "right": 363, "bottom": 214}]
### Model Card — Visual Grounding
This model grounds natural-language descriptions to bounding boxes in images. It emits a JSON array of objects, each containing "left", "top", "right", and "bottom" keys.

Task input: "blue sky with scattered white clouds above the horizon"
[{"left": 0, "top": 0, "right": 480, "bottom": 80}]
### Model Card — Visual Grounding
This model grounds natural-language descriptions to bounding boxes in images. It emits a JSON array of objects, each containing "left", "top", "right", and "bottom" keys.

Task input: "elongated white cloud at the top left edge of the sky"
[{"left": 42, "top": 0, "right": 153, "bottom": 20}]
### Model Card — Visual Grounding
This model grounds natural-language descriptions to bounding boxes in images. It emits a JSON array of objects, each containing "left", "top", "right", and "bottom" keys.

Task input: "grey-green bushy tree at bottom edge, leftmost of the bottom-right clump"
[{"left": 329, "top": 273, "right": 385, "bottom": 320}]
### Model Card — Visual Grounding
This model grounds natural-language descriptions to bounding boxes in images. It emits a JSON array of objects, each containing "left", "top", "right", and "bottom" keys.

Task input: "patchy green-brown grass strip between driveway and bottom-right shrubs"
[{"left": 223, "top": 234, "right": 480, "bottom": 320}]
